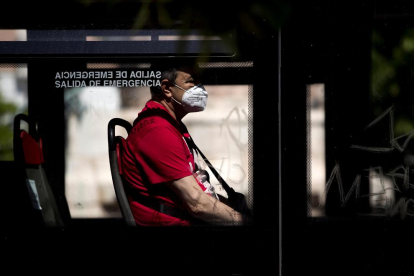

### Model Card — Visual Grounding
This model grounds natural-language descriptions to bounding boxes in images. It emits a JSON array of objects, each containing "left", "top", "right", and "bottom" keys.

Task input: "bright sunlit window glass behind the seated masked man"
[{"left": 64, "top": 63, "right": 253, "bottom": 218}]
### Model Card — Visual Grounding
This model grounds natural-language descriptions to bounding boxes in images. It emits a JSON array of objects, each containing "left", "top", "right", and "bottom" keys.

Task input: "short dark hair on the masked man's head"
[{"left": 150, "top": 58, "right": 198, "bottom": 99}]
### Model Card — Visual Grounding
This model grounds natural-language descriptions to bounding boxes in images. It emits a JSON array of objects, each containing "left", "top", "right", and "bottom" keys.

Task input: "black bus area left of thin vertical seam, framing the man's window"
[{"left": 0, "top": 1, "right": 283, "bottom": 275}]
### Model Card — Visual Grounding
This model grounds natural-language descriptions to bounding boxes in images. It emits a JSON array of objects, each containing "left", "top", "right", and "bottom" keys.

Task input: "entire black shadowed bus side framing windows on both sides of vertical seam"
[{"left": 0, "top": 1, "right": 414, "bottom": 276}]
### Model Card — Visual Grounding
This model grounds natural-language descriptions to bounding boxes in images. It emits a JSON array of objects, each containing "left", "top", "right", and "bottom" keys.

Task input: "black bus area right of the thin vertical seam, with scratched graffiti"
[{"left": 281, "top": 1, "right": 414, "bottom": 275}]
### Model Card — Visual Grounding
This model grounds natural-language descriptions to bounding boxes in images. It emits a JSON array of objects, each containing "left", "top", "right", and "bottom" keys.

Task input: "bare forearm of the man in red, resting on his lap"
[{"left": 170, "top": 175, "right": 246, "bottom": 225}]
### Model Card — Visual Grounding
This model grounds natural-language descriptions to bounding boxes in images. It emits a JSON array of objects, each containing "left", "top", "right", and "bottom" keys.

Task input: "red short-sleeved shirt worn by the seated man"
[{"left": 122, "top": 100, "right": 205, "bottom": 226}]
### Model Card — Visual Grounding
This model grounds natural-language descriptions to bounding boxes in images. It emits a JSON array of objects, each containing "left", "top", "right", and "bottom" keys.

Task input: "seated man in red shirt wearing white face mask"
[{"left": 123, "top": 60, "right": 246, "bottom": 226}]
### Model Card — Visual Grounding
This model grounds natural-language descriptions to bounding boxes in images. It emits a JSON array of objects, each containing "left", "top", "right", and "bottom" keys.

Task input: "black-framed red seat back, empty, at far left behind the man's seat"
[{"left": 13, "top": 114, "right": 64, "bottom": 227}]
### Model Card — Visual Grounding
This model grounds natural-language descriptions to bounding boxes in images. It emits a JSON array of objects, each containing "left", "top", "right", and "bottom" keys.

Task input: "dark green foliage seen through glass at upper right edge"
[{"left": 371, "top": 28, "right": 414, "bottom": 136}]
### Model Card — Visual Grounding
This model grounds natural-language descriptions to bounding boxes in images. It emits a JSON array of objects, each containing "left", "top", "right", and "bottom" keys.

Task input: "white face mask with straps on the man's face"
[{"left": 172, "top": 84, "right": 208, "bottom": 112}]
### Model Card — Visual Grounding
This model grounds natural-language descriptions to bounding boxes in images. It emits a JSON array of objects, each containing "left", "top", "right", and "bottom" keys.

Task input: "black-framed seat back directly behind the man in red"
[{"left": 108, "top": 118, "right": 137, "bottom": 227}]
